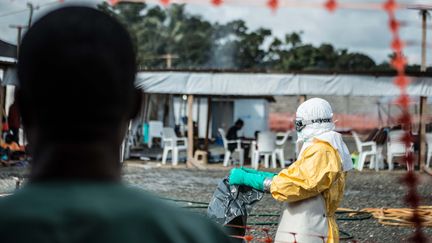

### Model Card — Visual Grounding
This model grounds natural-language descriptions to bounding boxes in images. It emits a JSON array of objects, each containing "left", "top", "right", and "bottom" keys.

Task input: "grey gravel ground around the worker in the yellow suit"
[{"left": 0, "top": 163, "right": 432, "bottom": 242}]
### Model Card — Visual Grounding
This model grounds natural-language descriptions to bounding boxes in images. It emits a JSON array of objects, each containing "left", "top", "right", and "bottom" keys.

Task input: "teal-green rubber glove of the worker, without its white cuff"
[{"left": 229, "top": 168, "right": 267, "bottom": 191}]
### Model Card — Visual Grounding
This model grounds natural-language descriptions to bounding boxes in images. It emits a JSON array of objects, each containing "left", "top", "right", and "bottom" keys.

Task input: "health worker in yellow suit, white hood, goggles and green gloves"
[{"left": 230, "top": 98, "right": 353, "bottom": 243}]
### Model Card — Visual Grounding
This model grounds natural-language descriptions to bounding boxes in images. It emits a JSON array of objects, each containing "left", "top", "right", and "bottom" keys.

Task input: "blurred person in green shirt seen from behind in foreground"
[{"left": 0, "top": 7, "right": 228, "bottom": 243}]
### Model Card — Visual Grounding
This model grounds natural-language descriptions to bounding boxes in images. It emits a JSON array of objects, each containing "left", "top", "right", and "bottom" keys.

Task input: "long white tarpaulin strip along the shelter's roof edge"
[{"left": 136, "top": 72, "right": 432, "bottom": 96}]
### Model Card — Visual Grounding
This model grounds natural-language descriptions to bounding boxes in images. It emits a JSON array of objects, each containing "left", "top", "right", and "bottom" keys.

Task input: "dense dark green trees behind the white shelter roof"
[{"left": 100, "top": 3, "right": 417, "bottom": 71}]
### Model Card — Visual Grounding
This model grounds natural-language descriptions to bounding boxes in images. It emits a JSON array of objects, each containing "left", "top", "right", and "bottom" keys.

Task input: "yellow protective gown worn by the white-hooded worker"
[{"left": 270, "top": 139, "right": 345, "bottom": 242}]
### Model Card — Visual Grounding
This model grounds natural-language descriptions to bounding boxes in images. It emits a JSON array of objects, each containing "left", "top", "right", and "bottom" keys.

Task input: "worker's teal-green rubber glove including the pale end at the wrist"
[{"left": 229, "top": 168, "right": 275, "bottom": 191}]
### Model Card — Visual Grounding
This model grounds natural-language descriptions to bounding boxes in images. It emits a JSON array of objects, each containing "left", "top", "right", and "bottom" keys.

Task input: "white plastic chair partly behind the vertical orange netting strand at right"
[{"left": 387, "top": 130, "right": 414, "bottom": 170}]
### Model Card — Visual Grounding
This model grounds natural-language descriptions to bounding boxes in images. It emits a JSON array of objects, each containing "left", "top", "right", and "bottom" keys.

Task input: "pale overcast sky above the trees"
[{"left": 0, "top": 0, "right": 432, "bottom": 65}]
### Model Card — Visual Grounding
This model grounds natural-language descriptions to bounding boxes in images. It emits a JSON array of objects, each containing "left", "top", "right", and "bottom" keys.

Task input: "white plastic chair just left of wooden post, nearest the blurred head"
[{"left": 162, "top": 127, "right": 187, "bottom": 165}]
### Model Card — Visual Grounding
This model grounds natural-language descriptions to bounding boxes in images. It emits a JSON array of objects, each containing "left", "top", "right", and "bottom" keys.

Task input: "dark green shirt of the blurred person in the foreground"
[{"left": 0, "top": 182, "right": 229, "bottom": 243}]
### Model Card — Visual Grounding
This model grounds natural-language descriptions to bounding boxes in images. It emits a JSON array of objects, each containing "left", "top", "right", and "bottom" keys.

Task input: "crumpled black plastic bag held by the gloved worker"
[{"left": 207, "top": 177, "right": 264, "bottom": 240}]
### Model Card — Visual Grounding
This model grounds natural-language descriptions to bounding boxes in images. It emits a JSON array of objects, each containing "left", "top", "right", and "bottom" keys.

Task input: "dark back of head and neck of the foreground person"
[{"left": 17, "top": 6, "right": 139, "bottom": 179}]
